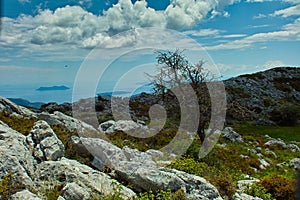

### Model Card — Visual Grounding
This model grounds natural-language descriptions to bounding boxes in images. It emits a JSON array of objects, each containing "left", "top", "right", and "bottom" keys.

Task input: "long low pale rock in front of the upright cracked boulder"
[{"left": 33, "top": 157, "right": 136, "bottom": 199}]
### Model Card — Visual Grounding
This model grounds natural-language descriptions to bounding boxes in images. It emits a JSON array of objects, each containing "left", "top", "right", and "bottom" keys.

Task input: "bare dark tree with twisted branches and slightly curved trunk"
[{"left": 148, "top": 49, "right": 215, "bottom": 142}]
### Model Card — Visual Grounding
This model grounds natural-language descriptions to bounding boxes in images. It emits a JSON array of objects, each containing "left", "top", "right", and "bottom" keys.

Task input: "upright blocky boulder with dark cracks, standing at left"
[{"left": 26, "top": 120, "right": 65, "bottom": 161}]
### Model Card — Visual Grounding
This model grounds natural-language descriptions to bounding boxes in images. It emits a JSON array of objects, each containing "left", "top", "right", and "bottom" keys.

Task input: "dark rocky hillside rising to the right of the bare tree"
[{"left": 224, "top": 67, "right": 300, "bottom": 125}]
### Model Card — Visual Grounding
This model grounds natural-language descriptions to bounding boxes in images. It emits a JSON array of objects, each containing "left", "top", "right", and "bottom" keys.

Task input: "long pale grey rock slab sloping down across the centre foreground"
[{"left": 82, "top": 138, "right": 222, "bottom": 199}]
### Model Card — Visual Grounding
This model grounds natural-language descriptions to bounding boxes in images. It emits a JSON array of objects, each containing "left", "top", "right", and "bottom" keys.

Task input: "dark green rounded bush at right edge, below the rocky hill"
[{"left": 270, "top": 105, "right": 300, "bottom": 126}]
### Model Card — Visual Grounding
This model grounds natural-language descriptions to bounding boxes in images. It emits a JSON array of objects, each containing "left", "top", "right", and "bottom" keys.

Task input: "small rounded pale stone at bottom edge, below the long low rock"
[{"left": 60, "top": 183, "right": 90, "bottom": 200}]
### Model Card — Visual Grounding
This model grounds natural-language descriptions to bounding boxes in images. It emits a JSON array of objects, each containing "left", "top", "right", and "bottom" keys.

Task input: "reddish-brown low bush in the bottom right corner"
[{"left": 261, "top": 175, "right": 296, "bottom": 200}]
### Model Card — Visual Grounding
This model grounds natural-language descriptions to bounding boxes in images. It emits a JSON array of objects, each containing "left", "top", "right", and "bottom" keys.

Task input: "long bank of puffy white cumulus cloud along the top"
[{"left": 0, "top": 0, "right": 237, "bottom": 51}]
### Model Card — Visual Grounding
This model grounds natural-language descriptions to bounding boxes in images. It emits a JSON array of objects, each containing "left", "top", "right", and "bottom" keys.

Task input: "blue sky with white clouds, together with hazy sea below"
[{"left": 0, "top": 0, "right": 300, "bottom": 102}]
